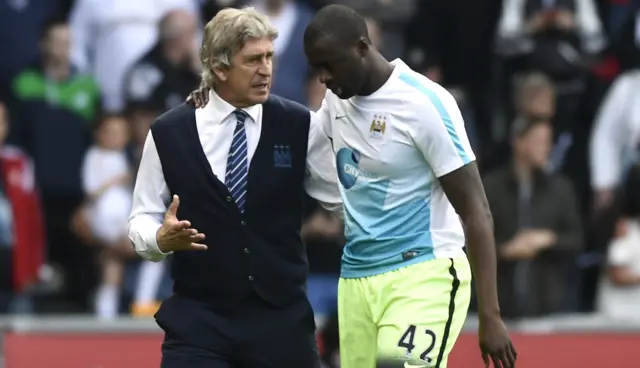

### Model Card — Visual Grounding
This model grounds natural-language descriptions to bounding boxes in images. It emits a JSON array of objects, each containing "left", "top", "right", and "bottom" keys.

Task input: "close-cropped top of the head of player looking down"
[{"left": 304, "top": 4, "right": 371, "bottom": 46}]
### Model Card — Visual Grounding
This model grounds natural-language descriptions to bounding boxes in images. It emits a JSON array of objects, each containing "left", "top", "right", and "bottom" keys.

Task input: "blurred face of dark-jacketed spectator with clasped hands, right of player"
[{"left": 516, "top": 123, "right": 553, "bottom": 169}]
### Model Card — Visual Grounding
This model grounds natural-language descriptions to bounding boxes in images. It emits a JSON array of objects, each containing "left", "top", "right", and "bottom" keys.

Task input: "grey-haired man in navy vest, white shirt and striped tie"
[{"left": 130, "top": 8, "right": 341, "bottom": 368}]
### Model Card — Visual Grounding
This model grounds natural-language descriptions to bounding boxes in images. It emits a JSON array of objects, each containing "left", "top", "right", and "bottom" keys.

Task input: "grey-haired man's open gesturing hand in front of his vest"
[{"left": 156, "top": 195, "right": 207, "bottom": 253}]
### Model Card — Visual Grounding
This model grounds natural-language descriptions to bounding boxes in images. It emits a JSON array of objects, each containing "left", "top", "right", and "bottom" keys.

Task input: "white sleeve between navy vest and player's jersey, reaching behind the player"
[{"left": 304, "top": 99, "right": 343, "bottom": 219}]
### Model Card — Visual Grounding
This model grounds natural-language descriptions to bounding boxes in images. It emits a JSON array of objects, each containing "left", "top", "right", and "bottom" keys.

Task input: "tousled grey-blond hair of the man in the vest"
[{"left": 200, "top": 7, "right": 278, "bottom": 88}]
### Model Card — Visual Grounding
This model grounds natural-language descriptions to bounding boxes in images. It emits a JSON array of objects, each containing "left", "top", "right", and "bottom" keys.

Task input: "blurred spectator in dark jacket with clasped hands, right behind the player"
[{"left": 484, "top": 117, "right": 582, "bottom": 318}]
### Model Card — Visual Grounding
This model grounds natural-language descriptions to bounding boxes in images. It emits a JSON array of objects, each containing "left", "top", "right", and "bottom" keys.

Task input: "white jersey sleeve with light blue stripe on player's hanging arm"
[{"left": 412, "top": 91, "right": 476, "bottom": 178}]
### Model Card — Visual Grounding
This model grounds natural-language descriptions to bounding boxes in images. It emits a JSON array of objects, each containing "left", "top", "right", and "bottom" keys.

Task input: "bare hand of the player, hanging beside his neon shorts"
[{"left": 478, "top": 316, "right": 518, "bottom": 368}]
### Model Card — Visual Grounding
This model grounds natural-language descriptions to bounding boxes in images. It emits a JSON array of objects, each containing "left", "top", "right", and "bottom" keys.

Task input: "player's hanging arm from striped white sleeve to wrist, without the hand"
[{"left": 416, "top": 95, "right": 500, "bottom": 316}]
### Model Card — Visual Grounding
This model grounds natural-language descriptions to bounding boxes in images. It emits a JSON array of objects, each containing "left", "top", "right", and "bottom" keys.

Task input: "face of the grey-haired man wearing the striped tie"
[{"left": 216, "top": 38, "right": 273, "bottom": 106}]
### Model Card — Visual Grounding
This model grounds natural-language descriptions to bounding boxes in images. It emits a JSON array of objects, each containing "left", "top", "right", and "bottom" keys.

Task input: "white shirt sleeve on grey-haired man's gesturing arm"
[{"left": 129, "top": 132, "right": 170, "bottom": 262}]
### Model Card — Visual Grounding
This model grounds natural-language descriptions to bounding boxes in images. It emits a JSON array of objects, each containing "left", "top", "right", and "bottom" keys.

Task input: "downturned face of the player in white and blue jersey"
[{"left": 304, "top": 38, "right": 368, "bottom": 99}]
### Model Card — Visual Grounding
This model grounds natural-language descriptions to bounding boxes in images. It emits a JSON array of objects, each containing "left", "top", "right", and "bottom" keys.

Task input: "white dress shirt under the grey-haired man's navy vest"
[{"left": 129, "top": 91, "right": 342, "bottom": 262}]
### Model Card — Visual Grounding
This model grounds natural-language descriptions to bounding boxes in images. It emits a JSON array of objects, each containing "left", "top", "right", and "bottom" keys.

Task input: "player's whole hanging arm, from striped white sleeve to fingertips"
[{"left": 413, "top": 91, "right": 516, "bottom": 368}]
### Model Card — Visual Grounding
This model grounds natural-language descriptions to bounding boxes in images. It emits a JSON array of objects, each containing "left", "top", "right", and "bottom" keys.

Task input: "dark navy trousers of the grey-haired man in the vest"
[{"left": 156, "top": 294, "right": 320, "bottom": 368}]
